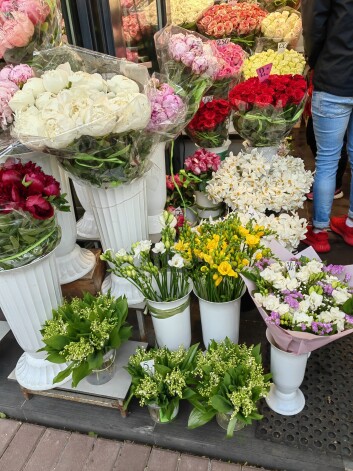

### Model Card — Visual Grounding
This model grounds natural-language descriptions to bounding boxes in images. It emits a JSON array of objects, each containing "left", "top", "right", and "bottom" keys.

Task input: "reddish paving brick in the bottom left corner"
[{"left": 0, "top": 424, "right": 45, "bottom": 471}]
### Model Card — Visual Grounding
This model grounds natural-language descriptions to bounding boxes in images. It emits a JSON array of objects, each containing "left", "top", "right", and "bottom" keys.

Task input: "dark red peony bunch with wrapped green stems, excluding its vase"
[{"left": 0, "top": 159, "right": 69, "bottom": 270}]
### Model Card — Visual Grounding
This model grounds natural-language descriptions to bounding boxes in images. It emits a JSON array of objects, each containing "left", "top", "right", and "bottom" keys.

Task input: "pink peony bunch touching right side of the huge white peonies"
[{"left": 146, "top": 74, "right": 188, "bottom": 141}]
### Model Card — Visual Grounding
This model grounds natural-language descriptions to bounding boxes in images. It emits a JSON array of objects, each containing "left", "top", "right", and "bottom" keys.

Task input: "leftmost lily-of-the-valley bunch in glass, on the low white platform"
[{"left": 39, "top": 293, "right": 131, "bottom": 387}]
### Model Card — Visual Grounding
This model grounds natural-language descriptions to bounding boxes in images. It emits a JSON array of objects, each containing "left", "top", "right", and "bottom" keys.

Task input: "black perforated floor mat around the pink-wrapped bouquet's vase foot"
[{"left": 256, "top": 335, "right": 353, "bottom": 457}]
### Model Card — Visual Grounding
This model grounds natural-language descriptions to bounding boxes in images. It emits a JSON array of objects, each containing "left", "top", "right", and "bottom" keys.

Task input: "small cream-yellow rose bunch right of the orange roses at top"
[{"left": 261, "top": 8, "right": 302, "bottom": 47}]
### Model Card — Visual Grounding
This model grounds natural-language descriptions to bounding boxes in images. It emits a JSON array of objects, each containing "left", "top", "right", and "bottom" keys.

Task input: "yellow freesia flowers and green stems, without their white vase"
[{"left": 174, "top": 214, "right": 271, "bottom": 302}]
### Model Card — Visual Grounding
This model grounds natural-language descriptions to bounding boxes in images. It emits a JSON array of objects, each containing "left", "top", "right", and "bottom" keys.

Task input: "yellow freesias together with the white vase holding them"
[{"left": 174, "top": 215, "right": 266, "bottom": 347}]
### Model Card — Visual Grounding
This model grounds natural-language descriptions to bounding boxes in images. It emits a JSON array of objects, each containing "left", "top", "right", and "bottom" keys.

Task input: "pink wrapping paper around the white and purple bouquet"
[{"left": 243, "top": 241, "right": 353, "bottom": 355}]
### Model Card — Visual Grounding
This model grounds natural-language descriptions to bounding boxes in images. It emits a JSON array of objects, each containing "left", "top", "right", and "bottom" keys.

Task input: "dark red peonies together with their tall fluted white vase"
[{"left": 0, "top": 159, "right": 68, "bottom": 390}]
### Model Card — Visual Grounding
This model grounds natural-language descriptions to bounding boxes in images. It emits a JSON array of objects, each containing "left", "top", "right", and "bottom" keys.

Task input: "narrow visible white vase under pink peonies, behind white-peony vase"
[{"left": 146, "top": 142, "right": 167, "bottom": 242}]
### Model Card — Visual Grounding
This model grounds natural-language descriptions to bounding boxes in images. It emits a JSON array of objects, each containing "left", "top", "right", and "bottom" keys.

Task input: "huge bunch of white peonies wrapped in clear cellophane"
[{"left": 9, "top": 46, "right": 154, "bottom": 187}]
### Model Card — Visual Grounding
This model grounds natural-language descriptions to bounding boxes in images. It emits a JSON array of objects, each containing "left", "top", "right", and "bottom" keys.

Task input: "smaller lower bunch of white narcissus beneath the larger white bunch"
[{"left": 236, "top": 211, "right": 308, "bottom": 252}]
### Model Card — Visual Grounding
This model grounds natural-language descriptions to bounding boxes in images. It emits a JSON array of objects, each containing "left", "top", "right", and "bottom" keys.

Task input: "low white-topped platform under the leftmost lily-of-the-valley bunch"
[{"left": 8, "top": 340, "right": 147, "bottom": 417}]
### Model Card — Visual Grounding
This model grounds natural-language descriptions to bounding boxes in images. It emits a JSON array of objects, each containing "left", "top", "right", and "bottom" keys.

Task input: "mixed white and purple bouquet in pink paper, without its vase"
[{"left": 244, "top": 243, "right": 353, "bottom": 354}]
